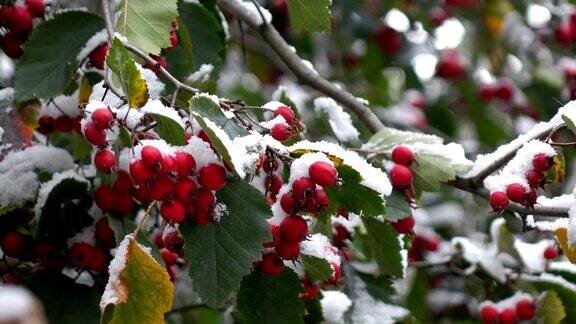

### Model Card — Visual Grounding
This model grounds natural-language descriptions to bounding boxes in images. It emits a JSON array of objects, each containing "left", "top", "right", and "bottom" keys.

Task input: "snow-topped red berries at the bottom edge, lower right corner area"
[{"left": 480, "top": 298, "right": 537, "bottom": 324}]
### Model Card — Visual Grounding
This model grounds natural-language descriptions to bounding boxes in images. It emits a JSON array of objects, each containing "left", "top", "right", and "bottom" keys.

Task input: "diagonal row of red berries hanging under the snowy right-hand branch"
[{"left": 490, "top": 153, "right": 554, "bottom": 213}]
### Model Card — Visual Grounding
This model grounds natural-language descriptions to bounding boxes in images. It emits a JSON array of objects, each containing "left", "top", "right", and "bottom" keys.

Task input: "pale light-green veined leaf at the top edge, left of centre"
[{"left": 116, "top": 0, "right": 178, "bottom": 54}]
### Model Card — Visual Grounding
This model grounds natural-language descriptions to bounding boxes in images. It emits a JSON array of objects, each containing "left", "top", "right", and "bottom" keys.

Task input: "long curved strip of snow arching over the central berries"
[{"left": 288, "top": 140, "right": 392, "bottom": 196}]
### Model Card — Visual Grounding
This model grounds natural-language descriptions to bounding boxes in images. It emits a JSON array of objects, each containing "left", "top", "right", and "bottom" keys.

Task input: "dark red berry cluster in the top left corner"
[{"left": 0, "top": 0, "right": 46, "bottom": 58}]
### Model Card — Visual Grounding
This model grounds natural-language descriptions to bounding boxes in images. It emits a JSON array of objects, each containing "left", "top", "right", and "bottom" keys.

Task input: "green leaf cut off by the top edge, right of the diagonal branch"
[{"left": 288, "top": 0, "right": 332, "bottom": 33}]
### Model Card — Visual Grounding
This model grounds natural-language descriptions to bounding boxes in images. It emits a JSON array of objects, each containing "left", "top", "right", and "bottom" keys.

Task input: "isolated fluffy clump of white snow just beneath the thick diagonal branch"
[{"left": 314, "top": 97, "right": 360, "bottom": 142}]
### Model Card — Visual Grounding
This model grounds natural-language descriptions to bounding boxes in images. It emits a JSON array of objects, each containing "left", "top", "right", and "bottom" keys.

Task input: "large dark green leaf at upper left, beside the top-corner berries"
[{"left": 14, "top": 11, "right": 104, "bottom": 102}]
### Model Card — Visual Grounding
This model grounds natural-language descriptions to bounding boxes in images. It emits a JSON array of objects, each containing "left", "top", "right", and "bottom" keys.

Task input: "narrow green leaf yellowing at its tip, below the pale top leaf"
[{"left": 106, "top": 38, "right": 148, "bottom": 108}]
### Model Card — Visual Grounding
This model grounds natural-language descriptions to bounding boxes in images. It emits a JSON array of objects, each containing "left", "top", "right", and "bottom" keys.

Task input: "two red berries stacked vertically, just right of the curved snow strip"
[{"left": 388, "top": 145, "right": 416, "bottom": 201}]
